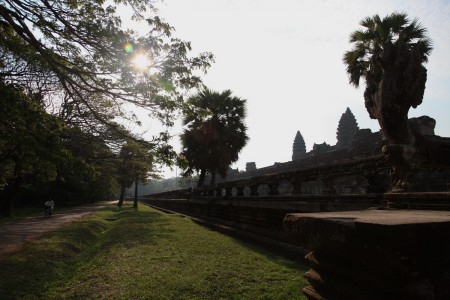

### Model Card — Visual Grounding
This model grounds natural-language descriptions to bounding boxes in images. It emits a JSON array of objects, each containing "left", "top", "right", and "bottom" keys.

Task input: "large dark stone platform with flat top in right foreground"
[{"left": 284, "top": 210, "right": 450, "bottom": 299}]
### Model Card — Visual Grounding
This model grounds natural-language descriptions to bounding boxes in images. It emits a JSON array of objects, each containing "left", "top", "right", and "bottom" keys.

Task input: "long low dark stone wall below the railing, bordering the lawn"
[{"left": 140, "top": 195, "right": 382, "bottom": 243}]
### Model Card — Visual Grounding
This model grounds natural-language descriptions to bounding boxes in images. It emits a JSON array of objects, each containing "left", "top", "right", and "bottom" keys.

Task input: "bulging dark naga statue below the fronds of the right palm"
[{"left": 364, "top": 42, "right": 427, "bottom": 145}]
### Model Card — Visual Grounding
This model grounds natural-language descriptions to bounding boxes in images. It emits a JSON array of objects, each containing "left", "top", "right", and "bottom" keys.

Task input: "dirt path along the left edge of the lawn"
[{"left": 0, "top": 201, "right": 117, "bottom": 259}]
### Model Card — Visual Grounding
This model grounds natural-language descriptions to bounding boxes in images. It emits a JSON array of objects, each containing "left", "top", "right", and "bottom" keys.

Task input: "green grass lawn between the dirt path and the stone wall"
[{"left": 0, "top": 203, "right": 307, "bottom": 300}]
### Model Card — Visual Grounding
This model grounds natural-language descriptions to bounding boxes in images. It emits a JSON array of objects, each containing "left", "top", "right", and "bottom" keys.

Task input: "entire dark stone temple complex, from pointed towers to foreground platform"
[{"left": 147, "top": 109, "right": 450, "bottom": 300}]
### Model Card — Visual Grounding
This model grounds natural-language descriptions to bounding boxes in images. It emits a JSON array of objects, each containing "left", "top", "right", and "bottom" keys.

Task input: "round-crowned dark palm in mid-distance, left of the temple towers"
[{"left": 181, "top": 88, "right": 249, "bottom": 188}]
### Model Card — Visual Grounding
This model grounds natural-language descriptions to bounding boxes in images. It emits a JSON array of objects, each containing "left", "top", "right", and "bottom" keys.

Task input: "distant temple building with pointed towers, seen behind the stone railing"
[{"left": 226, "top": 108, "right": 450, "bottom": 194}]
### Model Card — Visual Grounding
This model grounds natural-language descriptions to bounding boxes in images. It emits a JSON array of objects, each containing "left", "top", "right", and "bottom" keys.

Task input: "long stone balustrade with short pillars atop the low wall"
[{"left": 149, "top": 155, "right": 390, "bottom": 199}]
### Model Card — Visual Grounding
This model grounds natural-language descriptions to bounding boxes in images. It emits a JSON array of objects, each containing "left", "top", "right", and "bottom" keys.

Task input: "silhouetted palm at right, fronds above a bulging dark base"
[{"left": 343, "top": 13, "right": 432, "bottom": 144}]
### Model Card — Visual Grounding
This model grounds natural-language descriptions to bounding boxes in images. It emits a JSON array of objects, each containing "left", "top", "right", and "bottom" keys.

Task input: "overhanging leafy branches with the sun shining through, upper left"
[{"left": 0, "top": 0, "right": 213, "bottom": 151}]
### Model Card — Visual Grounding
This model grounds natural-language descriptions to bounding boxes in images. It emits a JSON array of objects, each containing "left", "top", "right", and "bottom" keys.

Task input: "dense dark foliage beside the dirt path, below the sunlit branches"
[{"left": 0, "top": 80, "right": 123, "bottom": 215}]
